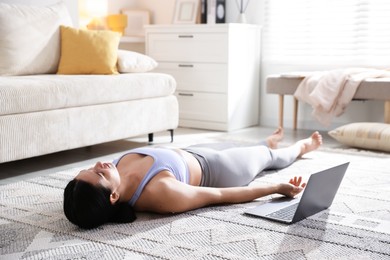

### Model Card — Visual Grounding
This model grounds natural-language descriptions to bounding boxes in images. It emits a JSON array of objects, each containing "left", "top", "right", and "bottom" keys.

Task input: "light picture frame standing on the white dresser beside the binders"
[{"left": 173, "top": 0, "right": 200, "bottom": 24}]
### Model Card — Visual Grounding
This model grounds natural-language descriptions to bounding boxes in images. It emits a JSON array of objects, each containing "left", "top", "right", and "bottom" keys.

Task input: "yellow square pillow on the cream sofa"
[{"left": 57, "top": 26, "right": 121, "bottom": 74}]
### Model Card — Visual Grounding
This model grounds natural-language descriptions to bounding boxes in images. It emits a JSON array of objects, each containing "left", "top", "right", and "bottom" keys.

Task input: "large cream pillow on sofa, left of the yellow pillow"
[{"left": 0, "top": 2, "right": 72, "bottom": 76}]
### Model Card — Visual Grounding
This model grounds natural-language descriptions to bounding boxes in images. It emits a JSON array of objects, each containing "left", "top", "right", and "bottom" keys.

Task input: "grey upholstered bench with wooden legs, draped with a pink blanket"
[{"left": 266, "top": 75, "right": 390, "bottom": 129}]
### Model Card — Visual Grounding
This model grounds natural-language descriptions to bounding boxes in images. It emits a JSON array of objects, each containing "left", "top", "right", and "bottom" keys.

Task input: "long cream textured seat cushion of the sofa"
[{"left": 0, "top": 73, "right": 176, "bottom": 115}]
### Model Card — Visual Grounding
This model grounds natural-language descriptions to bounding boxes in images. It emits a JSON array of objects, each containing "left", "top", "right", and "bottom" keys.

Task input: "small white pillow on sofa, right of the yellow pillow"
[{"left": 118, "top": 50, "right": 158, "bottom": 73}]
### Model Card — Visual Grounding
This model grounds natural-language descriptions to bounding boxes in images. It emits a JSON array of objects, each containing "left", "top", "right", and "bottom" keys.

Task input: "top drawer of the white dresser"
[{"left": 147, "top": 33, "right": 228, "bottom": 62}]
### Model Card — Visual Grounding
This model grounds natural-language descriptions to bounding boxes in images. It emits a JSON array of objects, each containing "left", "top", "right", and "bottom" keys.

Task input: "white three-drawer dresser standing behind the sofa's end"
[{"left": 145, "top": 24, "right": 260, "bottom": 131}]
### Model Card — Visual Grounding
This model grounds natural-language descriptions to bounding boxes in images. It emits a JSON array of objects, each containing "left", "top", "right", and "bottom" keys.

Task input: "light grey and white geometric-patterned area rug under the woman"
[{"left": 0, "top": 147, "right": 390, "bottom": 260}]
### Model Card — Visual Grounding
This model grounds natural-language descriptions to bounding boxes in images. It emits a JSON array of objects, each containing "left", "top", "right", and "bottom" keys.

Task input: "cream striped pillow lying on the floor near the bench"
[{"left": 328, "top": 123, "right": 390, "bottom": 152}]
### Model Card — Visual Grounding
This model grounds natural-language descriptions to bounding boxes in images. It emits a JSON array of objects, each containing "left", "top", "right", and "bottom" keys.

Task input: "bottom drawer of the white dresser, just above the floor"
[{"left": 176, "top": 91, "right": 228, "bottom": 123}]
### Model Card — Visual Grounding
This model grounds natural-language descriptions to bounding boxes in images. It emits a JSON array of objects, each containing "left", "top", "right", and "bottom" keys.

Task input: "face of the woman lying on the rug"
[{"left": 75, "top": 162, "right": 121, "bottom": 191}]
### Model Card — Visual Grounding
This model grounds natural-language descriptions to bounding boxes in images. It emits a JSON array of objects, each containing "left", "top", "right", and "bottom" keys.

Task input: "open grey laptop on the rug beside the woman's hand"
[{"left": 245, "top": 162, "right": 349, "bottom": 224}]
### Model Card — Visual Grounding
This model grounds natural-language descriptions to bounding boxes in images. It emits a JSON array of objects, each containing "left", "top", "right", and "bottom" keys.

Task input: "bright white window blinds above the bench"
[{"left": 263, "top": 0, "right": 390, "bottom": 67}]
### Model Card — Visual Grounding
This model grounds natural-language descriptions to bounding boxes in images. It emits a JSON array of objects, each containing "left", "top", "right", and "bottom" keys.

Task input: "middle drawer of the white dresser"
[{"left": 156, "top": 62, "right": 228, "bottom": 93}]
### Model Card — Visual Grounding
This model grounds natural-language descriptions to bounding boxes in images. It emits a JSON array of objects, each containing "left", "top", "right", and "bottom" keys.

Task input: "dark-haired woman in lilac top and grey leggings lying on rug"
[{"left": 64, "top": 128, "right": 322, "bottom": 228}]
